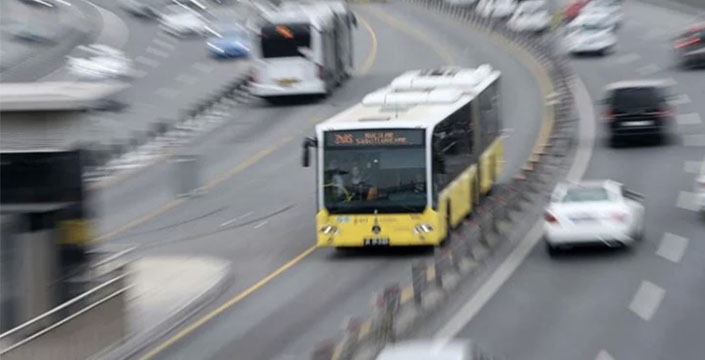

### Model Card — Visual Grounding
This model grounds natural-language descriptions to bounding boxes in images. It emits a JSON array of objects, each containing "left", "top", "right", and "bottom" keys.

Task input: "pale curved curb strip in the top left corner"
[{"left": 0, "top": 0, "right": 103, "bottom": 82}]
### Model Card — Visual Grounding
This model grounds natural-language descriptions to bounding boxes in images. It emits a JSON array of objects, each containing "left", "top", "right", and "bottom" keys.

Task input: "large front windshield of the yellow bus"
[{"left": 323, "top": 130, "right": 427, "bottom": 214}]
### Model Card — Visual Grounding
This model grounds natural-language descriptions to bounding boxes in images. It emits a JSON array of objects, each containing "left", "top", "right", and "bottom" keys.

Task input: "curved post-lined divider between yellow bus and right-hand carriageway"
[{"left": 312, "top": 0, "right": 577, "bottom": 360}]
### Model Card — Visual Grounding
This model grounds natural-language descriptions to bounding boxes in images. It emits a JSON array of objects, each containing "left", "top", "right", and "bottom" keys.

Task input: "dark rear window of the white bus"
[{"left": 260, "top": 24, "right": 311, "bottom": 59}]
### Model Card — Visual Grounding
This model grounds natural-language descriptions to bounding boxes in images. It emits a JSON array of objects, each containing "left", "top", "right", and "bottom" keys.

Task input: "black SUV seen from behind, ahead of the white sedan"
[{"left": 603, "top": 81, "right": 673, "bottom": 145}]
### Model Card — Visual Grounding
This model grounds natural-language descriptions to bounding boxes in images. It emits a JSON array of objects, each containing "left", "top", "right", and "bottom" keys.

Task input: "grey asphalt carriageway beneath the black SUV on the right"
[{"left": 412, "top": 2, "right": 705, "bottom": 360}]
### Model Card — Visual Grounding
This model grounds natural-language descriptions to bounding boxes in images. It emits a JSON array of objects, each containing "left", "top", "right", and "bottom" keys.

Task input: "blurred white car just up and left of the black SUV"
[{"left": 564, "top": 14, "right": 618, "bottom": 55}]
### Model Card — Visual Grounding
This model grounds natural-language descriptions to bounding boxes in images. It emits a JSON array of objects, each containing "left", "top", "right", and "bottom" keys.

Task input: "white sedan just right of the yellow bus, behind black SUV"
[{"left": 544, "top": 180, "right": 645, "bottom": 254}]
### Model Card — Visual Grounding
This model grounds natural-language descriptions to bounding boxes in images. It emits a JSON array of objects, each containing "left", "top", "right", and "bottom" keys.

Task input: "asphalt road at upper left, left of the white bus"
[{"left": 42, "top": 0, "right": 253, "bottom": 144}]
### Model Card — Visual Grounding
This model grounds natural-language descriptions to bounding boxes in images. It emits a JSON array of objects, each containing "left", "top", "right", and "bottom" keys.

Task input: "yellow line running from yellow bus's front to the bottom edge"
[{"left": 140, "top": 246, "right": 316, "bottom": 360}]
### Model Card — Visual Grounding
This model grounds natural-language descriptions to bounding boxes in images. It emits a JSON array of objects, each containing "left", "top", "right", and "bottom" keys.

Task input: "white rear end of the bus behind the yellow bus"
[{"left": 250, "top": 23, "right": 328, "bottom": 98}]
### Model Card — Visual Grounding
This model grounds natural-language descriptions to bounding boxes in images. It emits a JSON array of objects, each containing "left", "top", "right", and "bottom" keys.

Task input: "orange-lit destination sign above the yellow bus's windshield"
[{"left": 326, "top": 129, "right": 424, "bottom": 147}]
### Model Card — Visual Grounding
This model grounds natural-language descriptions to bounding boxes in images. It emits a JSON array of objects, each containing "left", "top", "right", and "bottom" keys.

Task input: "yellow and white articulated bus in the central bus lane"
[{"left": 302, "top": 65, "right": 504, "bottom": 248}]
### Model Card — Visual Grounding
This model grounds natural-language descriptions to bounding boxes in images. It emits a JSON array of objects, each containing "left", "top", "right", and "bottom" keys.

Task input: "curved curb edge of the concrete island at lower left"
[{"left": 95, "top": 258, "right": 234, "bottom": 360}]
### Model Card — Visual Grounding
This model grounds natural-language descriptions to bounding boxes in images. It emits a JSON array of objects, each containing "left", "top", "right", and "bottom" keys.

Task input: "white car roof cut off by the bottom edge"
[{"left": 375, "top": 340, "right": 498, "bottom": 360}]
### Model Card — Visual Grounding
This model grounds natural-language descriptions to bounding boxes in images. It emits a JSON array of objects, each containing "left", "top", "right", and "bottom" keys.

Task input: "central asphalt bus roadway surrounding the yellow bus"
[{"left": 89, "top": 4, "right": 543, "bottom": 360}]
